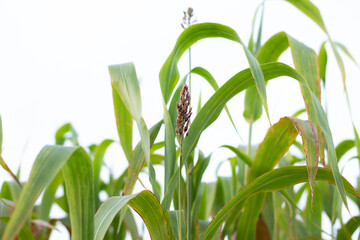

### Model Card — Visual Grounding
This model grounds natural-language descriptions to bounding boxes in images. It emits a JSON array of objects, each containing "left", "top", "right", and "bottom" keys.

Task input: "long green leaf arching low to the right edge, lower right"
[{"left": 202, "top": 166, "right": 360, "bottom": 240}]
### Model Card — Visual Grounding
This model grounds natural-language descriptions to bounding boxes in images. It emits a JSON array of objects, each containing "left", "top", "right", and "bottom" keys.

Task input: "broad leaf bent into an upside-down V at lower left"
[{"left": 2, "top": 146, "right": 94, "bottom": 240}]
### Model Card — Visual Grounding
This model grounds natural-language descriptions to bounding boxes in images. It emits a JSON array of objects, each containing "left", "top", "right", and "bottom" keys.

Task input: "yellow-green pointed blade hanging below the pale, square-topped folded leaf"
[{"left": 112, "top": 86, "right": 133, "bottom": 161}]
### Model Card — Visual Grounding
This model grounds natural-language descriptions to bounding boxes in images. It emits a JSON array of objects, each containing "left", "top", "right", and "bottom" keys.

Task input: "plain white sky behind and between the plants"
[{"left": 0, "top": 0, "right": 360, "bottom": 239}]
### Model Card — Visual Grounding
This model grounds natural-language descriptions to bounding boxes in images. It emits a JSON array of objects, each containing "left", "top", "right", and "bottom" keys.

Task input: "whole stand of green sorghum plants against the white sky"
[{"left": 0, "top": 0, "right": 360, "bottom": 240}]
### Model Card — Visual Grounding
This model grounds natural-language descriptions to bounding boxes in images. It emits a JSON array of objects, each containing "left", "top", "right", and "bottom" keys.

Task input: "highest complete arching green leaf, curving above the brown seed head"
[{"left": 159, "top": 23, "right": 268, "bottom": 122}]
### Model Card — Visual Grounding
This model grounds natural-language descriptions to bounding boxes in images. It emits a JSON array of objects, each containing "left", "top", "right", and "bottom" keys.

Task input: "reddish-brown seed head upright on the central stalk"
[{"left": 176, "top": 85, "right": 192, "bottom": 138}]
